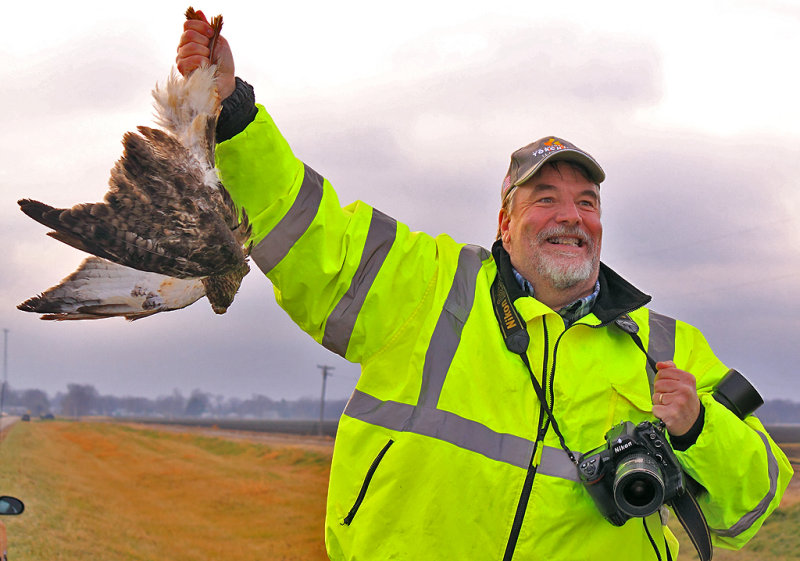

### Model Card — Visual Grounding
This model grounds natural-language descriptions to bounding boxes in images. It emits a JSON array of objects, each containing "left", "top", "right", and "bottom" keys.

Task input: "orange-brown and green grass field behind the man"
[{"left": 0, "top": 421, "right": 800, "bottom": 561}]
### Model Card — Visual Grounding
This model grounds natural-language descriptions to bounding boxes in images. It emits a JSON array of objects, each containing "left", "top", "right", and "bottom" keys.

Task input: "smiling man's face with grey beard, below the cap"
[{"left": 500, "top": 162, "right": 603, "bottom": 297}]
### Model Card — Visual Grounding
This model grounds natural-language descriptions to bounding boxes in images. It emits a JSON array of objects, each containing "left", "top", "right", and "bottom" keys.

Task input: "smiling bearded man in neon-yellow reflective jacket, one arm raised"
[{"left": 177, "top": 14, "right": 791, "bottom": 560}]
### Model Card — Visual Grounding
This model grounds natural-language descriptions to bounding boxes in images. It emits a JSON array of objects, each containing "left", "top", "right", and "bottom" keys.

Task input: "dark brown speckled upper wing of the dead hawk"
[{"left": 19, "top": 118, "right": 245, "bottom": 278}]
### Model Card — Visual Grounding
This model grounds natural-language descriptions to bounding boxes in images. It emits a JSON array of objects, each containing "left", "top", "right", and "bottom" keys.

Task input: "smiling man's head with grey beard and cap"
[{"left": 499, "top": 137, "right": 605, "bottom": 309}]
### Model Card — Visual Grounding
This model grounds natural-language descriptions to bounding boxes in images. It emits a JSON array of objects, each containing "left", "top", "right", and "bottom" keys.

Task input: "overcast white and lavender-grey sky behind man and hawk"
[{"left": 0, "top": 0, "right": 800, "bottom": 401}]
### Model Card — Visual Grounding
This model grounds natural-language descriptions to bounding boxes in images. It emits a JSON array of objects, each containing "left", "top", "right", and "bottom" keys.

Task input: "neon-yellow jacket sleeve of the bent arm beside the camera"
[{"left": 676, "top": 324, "right": 792, "bottom": 549}]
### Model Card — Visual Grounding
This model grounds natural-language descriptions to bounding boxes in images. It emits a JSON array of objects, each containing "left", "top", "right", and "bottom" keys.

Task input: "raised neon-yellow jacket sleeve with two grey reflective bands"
[{"left": 216, "top": 106, "right": 457, "bottom": 362}]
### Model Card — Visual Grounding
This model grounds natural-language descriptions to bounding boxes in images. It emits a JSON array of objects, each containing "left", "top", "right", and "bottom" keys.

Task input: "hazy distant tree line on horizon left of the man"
[{"left": 0, "top": 384, "right": 347, "bottom": 419}]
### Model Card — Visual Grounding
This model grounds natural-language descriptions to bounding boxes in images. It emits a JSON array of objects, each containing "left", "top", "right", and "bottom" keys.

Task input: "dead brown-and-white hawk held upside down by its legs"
[{"left": 18, "top": 8, "right": 250, "bottom": 319}]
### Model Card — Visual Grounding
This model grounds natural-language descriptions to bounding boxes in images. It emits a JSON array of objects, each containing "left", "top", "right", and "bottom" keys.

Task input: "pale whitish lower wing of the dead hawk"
[{"left": 17, "top": 257, "right": 205, "bottom": 320}]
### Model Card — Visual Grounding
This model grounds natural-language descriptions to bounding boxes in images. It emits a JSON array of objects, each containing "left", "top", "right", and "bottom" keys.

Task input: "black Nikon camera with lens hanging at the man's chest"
[{"left": 578, "top": 421, "right": 684, "bottom": 526}]
